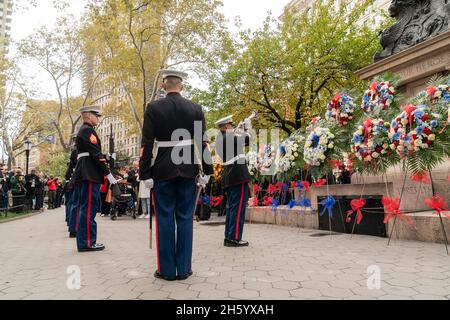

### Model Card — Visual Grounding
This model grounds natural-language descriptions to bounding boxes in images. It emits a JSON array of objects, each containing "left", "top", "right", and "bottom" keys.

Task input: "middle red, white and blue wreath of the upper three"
[{"left": 361, "top": 81, "right": 395, "bottom": 114}]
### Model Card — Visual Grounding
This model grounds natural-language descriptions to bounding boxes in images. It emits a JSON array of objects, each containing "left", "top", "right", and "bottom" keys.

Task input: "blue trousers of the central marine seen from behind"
[{"left": 153, "top": 178, "right": 195, "bottom": 278}]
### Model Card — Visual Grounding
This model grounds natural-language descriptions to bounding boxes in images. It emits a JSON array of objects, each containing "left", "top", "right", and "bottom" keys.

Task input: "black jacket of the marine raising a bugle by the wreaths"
[{"left": 216, "top": 131, "right": 251, "bottom": 188}]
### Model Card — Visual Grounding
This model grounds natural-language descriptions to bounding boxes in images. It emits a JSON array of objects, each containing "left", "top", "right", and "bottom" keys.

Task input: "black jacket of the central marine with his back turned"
[{"left": 139, "top": 93, "right": 213, "bottom": 181}]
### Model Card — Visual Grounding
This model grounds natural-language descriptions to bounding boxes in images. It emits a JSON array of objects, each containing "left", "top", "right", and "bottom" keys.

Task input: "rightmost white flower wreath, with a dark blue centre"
[{"left": 303, "top": 127, "right": 335, "bottom": 167}]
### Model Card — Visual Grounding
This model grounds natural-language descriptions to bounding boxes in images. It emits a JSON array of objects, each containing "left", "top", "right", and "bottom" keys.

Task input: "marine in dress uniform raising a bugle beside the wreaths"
[{"left": 216, "top": 116, "right": 251, "bottom": 247}]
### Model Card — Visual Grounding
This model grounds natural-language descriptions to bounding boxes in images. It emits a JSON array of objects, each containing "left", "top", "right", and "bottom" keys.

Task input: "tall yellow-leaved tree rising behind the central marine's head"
[{"left": 84, "top": 0, "right": 228, "bottom": 133}]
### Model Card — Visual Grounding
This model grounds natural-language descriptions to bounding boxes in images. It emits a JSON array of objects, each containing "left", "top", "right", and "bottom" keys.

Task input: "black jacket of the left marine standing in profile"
[{"left": 72, "top": 123, "right": 109, "bottom": 184}]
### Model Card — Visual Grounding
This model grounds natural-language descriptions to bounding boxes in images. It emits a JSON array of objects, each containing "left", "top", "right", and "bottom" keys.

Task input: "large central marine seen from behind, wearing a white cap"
[{"left": 139, "top": 70, "right": 213, "bottom": 281}]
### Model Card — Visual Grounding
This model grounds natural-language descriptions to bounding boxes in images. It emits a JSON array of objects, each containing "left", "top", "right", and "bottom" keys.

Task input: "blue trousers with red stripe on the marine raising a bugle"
[{"left": 225, "top": 183, "right": 250, "bottom": 241}]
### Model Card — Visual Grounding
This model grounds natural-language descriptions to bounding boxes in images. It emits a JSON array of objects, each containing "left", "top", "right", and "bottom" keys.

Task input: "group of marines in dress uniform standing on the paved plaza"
[{"left": 66, "top": 70, "right": 250, "bottom": 281}]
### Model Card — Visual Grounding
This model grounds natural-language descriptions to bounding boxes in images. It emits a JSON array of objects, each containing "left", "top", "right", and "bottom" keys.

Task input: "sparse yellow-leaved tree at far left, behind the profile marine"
[{"left": 18, "top": 15, "right": 116, "bottom": 152}]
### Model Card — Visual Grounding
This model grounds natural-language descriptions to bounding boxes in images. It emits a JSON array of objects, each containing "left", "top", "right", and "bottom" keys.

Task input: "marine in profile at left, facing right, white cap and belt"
[{"left": 72, "top": 106, "right": 117, "bottom": 252}]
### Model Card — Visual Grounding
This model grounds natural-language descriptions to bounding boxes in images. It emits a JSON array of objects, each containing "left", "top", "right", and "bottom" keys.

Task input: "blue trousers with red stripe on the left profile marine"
[{"left": 76, "top": 181, "right": 101, "bottom": 250}]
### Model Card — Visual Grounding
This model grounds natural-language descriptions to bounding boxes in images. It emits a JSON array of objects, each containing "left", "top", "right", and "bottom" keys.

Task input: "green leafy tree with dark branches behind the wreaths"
[{"left": 196, "top": 0, "right": 388, "bottom": 134}]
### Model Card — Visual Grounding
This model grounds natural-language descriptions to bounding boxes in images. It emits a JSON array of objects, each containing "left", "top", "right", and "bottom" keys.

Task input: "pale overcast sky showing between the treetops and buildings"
[{"left": 11, "top": 0, "right": 289, "bottom": 98}]
